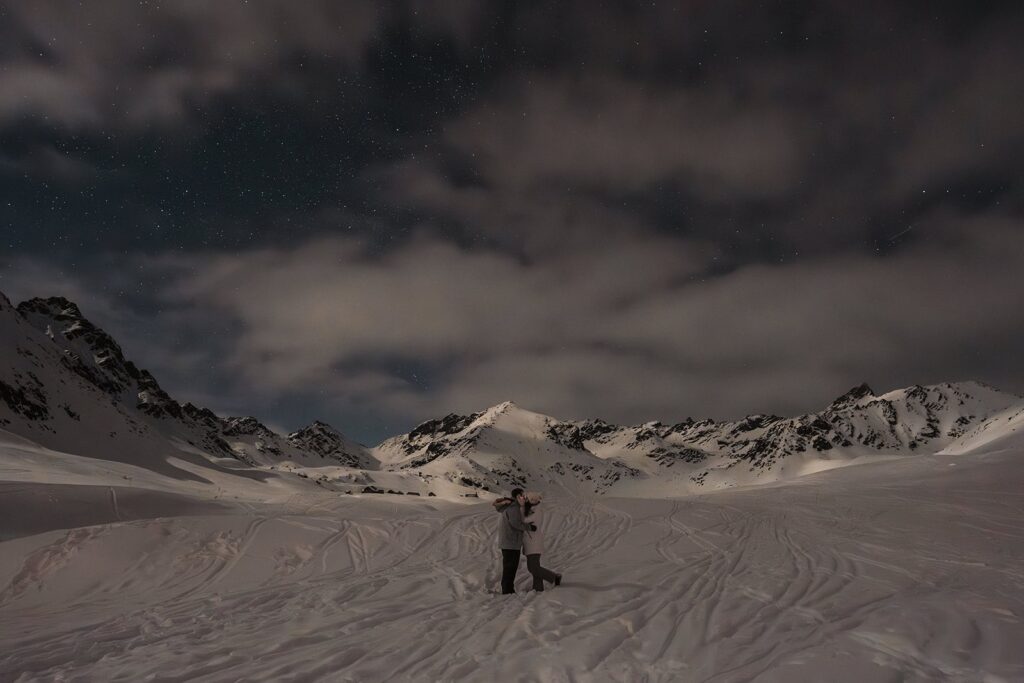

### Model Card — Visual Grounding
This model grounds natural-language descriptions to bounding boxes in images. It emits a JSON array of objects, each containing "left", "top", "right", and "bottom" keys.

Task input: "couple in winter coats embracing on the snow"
[{"left": 494, "top": 488, "right": 562, "bottom": 595}]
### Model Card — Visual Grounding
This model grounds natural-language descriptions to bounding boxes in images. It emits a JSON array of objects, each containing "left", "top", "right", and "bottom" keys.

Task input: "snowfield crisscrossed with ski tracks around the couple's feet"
[{"left": 0, "top": 448, "right": 1024, "bottom": 682}]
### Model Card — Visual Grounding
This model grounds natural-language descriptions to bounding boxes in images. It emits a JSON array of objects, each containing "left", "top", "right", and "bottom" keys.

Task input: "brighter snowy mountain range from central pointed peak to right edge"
[{"left": 374, "top": 382, "right": 1024, "bottom": 495}]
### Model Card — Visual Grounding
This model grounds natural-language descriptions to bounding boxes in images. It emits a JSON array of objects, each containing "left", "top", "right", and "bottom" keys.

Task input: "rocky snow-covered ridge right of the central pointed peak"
[{"left": 573, "top": 382, "right": 1024, "bottom": 493}]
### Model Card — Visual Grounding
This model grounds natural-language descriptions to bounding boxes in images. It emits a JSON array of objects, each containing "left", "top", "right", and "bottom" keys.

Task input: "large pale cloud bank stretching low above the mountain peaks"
[{"left": 155, "top": 209, "right": 1024, "bottom": 432}]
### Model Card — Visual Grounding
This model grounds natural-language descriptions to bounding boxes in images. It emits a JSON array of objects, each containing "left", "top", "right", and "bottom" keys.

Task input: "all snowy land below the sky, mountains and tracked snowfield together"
[{"left": 0, "top": 295, "right": 1024, "bottom": 681}]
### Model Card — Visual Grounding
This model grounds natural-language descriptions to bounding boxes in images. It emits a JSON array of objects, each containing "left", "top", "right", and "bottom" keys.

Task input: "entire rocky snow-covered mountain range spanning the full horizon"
[{"left": 0, "top": 294, "right": 1024, "bottom": 498}]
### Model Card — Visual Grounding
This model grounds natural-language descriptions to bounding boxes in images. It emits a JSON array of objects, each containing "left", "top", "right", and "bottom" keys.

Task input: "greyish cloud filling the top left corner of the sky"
[{"left": 0, "top": 0, "right": 382, "bottom": 130}]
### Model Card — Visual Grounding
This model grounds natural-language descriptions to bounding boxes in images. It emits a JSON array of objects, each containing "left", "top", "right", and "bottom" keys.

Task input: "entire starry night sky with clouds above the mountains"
[{"left": 0, "top": 0, "right": 1024, "bottom": 443}]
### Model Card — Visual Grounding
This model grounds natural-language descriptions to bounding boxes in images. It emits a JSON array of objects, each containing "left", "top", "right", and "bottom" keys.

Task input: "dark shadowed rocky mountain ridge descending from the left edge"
[{"left": 0, "top": 294, "right": 375, "bottom": 481}]
